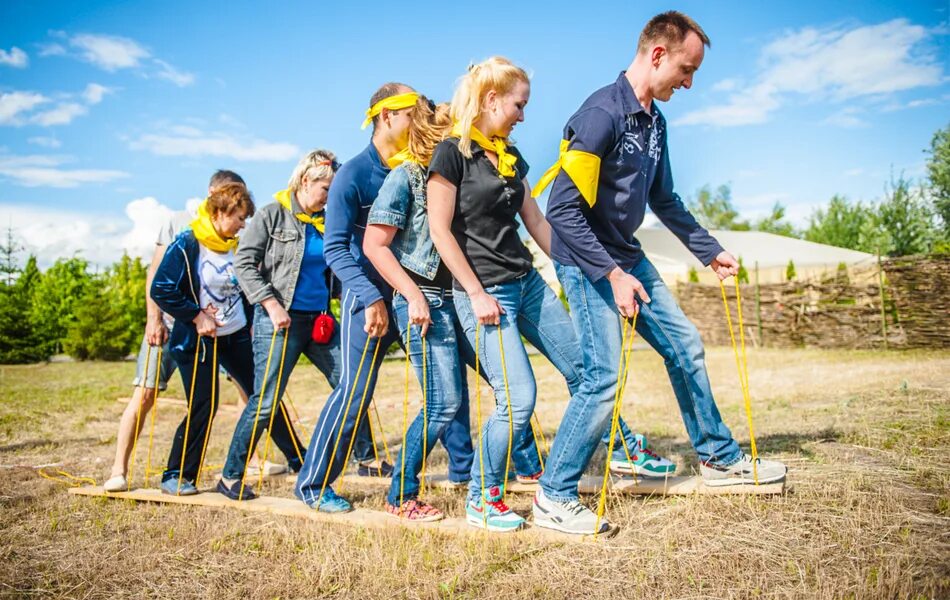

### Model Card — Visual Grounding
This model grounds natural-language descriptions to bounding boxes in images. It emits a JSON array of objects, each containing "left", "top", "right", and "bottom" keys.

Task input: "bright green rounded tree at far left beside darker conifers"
[{"left": 31, "top": 257, "right": 92, "bottom": 355}]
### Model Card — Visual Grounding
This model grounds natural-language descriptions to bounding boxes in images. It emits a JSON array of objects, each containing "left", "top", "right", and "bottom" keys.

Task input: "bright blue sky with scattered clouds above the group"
[{"left": 0, "top": 0, "right": 950, "bottom": 264}]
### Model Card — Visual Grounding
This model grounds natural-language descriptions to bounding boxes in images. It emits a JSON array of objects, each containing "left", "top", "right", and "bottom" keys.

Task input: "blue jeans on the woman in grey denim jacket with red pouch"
[{"left": 222, "top": 305, "right": 341, "bottom": 479}]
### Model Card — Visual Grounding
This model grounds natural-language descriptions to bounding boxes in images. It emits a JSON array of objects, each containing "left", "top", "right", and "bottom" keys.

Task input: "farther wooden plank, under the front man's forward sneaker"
[{"left": 328, "top": 475, "right": 786, "bottom": 496}]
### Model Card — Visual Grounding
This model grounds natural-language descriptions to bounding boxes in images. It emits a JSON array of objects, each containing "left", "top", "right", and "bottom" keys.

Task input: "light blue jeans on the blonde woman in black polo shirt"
[{"left": 455, "top": 269, "right": 600, "bottom": 499}]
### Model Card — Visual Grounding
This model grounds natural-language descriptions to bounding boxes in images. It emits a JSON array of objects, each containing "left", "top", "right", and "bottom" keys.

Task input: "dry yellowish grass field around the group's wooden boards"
[{"left": 0, "top": 348, "right": 950, "bottom": 599}]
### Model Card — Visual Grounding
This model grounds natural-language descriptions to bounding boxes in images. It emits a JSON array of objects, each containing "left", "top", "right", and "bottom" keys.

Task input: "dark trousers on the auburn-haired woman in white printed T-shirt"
[{"left": 162, "top": 327, "right": 255, "bottom": 481}]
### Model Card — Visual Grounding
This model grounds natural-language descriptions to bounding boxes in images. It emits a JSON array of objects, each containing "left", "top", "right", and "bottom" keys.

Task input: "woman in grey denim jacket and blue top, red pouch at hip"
[{"left": 218, "top": 150, "right": 384, "bottom": 500}]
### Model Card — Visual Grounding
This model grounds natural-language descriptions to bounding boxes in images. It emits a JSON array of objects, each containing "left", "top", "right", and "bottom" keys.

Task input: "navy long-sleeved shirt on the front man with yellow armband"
[{"left": 546, "top": 73, "right": 723, "bottom": 281}]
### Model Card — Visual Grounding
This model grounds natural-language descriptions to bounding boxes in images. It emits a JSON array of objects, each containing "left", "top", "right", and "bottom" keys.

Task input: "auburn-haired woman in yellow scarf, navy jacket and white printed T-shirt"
[{"left": 151, "top": 183, "right": 254, "bottom": 496}]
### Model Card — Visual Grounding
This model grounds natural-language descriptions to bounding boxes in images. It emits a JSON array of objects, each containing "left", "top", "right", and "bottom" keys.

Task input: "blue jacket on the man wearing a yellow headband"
[{"left": 323, "top": 142, "right": 392, "bottom": 307}]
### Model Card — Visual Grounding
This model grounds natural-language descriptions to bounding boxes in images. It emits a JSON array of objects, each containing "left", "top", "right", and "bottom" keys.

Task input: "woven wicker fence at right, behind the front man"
[{"left": 677, "top": 255, "right": 950, "bottom": 348}]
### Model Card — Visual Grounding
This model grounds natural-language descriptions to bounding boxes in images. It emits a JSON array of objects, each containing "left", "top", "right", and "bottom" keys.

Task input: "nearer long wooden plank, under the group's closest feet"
[{"left": 69, "top": 486, "right": 617, "bottom": 543}]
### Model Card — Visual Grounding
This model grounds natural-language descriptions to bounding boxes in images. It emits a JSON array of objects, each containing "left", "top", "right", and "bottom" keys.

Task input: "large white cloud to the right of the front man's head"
[{"left": 676, "top": 19, "right": 944, "bottom": 127}]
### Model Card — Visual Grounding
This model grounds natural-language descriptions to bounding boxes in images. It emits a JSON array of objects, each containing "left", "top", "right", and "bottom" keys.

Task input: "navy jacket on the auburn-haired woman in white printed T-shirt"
[{"left": 149, "top": 229, "right": 253, "bottom": 361}]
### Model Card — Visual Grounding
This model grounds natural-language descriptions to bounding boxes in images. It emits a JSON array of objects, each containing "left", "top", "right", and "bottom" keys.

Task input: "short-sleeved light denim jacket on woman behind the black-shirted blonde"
[{"left": 367, "top": 162, "right": 442, "bottom": 279}]
